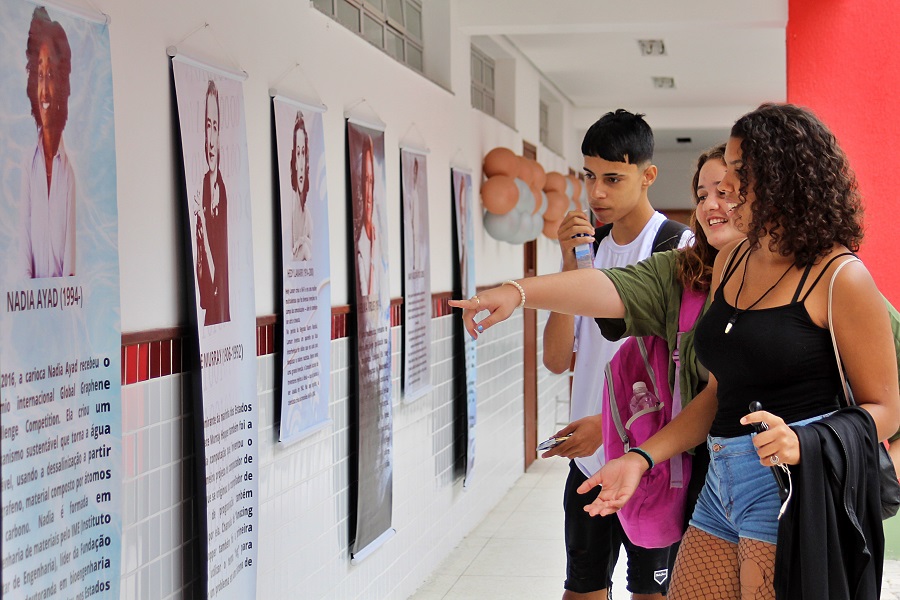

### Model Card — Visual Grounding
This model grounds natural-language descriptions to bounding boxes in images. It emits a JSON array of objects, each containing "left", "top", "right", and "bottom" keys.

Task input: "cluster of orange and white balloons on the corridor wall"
[{"left": 481, "top": 147, "right": 582, "bottom": 244}]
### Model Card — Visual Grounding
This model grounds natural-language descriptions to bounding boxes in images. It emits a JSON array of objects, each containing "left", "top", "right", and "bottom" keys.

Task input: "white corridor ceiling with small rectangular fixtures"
[{"left": 454, "top": 0, "right": 788, "bottom": 150}]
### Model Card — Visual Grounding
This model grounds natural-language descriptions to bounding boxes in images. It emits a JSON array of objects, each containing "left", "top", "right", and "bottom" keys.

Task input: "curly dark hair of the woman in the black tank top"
[{"left": 731, "top": 103, "right": 863, "bottom": 266}]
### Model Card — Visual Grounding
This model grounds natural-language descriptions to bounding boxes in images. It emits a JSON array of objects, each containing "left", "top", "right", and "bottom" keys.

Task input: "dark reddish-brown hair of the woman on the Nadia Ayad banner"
[{"left": 25, "top": 6, "right": 72, "bottom": 132}]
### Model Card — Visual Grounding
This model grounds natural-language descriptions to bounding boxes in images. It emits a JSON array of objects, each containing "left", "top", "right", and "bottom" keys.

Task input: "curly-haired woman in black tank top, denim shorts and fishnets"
[{"left": 580, "top": 104, "right": 900, "bottom": 600}]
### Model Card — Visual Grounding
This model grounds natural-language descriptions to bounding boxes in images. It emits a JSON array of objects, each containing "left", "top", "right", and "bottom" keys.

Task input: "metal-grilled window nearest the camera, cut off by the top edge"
[{"left": 313, "top": 0, "right": 425, "bottom": 73}]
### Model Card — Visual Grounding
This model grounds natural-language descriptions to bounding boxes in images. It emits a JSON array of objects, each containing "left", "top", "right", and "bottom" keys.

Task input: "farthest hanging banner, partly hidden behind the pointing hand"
[{"left": 451, "top": 169, "right": 478, "bottom": 485}]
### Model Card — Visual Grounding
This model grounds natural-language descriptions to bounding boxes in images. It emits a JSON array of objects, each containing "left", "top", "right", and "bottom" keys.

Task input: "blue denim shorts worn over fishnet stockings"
[{"left": 691, "top": 413, "right": 830, "bottom": 544}]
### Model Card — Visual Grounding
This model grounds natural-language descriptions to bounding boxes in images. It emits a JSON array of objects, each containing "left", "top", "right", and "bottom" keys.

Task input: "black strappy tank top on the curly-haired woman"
[{"left": 694, "top": 242, "right": 844, "bottom": 437}]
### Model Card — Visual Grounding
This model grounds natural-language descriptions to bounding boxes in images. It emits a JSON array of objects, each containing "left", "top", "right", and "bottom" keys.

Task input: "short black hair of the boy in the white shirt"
[{"left": 581, "top": 108, "right": 653, "bottom": 164}]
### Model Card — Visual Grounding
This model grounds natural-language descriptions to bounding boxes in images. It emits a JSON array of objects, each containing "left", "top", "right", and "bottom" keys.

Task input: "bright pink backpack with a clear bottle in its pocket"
[{"left": 601, "top": 289, "right": 707, "bottom": 548}]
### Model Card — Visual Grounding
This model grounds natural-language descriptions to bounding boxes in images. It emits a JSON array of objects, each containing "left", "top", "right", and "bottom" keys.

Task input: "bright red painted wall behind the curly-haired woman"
[{"left": 787, "top": 0, "right": 900, "bottom": 306}]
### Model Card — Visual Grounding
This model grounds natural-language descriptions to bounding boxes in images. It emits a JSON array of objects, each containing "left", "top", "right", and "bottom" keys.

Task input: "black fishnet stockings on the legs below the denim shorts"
[{"left": 668, "top": 527, "right": 775, "bottom": 600}]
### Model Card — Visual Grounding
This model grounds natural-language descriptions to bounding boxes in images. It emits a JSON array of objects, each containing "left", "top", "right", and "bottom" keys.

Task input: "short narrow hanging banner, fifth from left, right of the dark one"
[{"left": 400, "top": 149, "right": 431, "bottom": 402}]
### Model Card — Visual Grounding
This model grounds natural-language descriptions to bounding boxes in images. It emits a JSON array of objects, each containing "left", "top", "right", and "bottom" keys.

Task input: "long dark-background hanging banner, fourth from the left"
[{"left": 347, "top": 120, "right": 394, "bottom": 561}]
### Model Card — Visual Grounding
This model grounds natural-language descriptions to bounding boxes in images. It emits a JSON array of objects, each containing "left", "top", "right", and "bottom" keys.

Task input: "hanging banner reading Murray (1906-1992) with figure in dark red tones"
[{"left": 172, "top": 55, "right": 259, "bottom": 599}]
